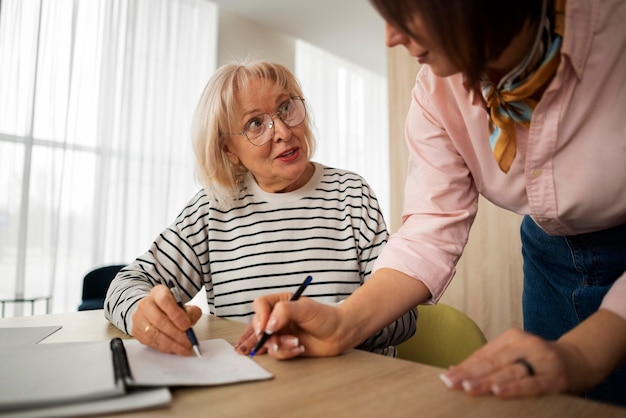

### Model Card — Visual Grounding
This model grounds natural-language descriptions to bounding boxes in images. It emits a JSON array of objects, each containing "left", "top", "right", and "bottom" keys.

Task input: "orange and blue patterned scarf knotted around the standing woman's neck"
[{"left": 481, "top": 0, "right": 565, "bottom": 173}]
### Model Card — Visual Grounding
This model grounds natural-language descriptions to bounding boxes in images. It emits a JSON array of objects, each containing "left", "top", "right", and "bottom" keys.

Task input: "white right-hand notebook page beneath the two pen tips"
[{"left": 124, "top": 339, "right": 273, "bottom": 386}]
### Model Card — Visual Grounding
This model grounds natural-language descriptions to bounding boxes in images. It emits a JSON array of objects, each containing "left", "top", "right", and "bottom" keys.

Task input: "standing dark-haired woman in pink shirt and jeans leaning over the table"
[{"left": 249, "top": 0, "right": 626, "bottom": 404}]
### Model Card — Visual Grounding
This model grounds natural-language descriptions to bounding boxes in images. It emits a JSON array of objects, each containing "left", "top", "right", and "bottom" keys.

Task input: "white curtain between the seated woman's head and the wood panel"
[{"left": 295, "top": 41, "right": 390, "bottom": 220}]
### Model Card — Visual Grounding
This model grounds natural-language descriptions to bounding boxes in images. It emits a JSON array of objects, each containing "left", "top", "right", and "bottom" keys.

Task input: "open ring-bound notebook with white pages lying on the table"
[{"left": 0, "top": 338, "right": 273, "bottom": 416}]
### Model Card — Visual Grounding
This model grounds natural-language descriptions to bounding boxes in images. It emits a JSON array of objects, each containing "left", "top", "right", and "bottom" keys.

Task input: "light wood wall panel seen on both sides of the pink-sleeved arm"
[{"left": 387, "top": 48, "right": 523, "bottom": 339}]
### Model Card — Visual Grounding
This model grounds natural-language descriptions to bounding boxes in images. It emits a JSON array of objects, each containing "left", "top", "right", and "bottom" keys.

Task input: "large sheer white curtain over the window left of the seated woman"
[{"left": 0, "top": 0, "right": 217, "bottom": 316}]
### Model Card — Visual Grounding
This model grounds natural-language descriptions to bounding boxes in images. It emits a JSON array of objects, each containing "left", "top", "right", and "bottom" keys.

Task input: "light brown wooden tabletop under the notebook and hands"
[{"left": 0, "top": 310, "right": 626, "bottom": 418}]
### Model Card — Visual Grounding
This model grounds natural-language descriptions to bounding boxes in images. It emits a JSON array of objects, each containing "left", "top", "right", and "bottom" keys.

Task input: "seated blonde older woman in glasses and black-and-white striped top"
[{"left": 104, "top": 61, "right": 416, "bottom": 356}]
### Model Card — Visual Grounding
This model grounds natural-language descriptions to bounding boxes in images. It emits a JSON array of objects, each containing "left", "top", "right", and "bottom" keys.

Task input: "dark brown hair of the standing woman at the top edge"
[{"left": 370, "top": 0, "right": 552, "bottom": 81}]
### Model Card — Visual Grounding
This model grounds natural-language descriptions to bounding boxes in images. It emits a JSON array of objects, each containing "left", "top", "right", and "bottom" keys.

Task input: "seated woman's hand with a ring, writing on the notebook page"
[{"left": 132, "top": 285, "right": 202, "bottom": 356}]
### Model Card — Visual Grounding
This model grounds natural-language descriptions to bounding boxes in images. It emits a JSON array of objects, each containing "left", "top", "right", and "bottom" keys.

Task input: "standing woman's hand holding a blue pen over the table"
[{"left": 252, "top": 293, "right": 348, "bottom": 359}]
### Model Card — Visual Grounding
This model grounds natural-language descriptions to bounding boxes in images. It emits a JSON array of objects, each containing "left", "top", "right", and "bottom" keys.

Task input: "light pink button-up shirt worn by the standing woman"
[{"left": 375, "top": 0, "right": 626, "bottom": 318}]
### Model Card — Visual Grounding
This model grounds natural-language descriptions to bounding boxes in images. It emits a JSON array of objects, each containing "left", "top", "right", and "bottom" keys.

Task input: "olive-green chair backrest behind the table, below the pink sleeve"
[{"left": 397, "top": 303, "right": 487, "bottom": 368}]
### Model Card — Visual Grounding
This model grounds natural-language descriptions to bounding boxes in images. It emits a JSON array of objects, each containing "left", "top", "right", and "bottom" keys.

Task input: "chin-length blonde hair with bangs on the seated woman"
[{"left": 192, "top": 60, "right": 315, "bottom": 207}]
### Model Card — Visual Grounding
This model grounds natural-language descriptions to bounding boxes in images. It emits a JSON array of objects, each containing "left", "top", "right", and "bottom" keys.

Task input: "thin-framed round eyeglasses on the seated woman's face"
[{"left": 231, "top": 96, "right": 306, "bottom": 147}]
